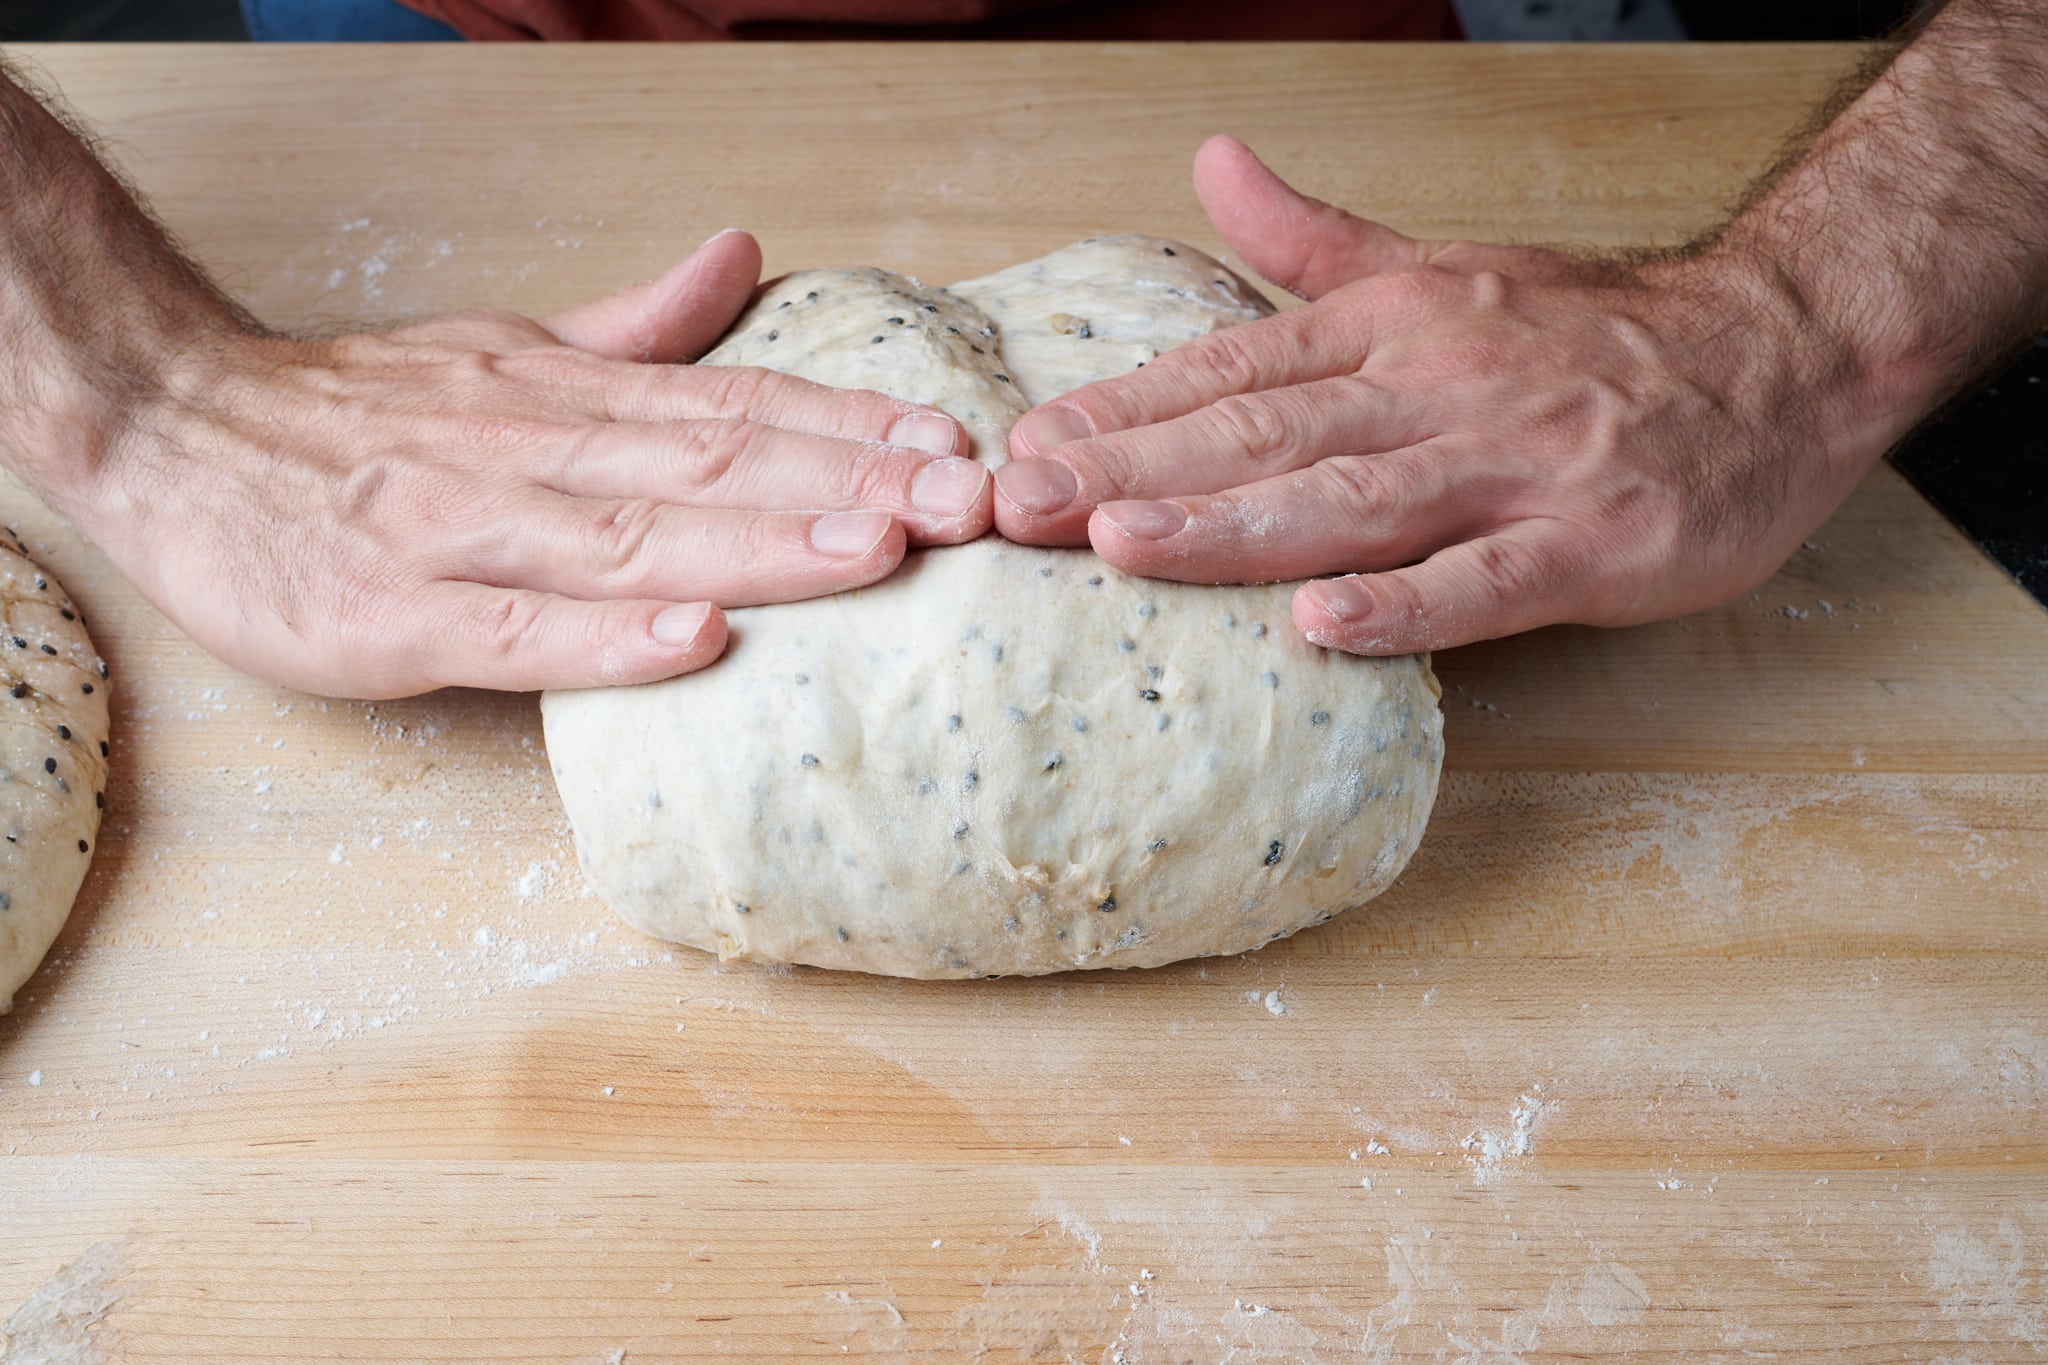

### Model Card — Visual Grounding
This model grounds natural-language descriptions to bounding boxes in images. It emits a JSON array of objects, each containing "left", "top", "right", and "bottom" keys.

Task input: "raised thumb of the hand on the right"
[{"left": 1194, "top": 135, "right": 1438, "bottom": 299}]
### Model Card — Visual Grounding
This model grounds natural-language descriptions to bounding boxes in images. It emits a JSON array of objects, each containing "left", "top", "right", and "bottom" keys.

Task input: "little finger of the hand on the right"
[{"left": 1294, "top": 524, "right": 1585, "bottom": 655}]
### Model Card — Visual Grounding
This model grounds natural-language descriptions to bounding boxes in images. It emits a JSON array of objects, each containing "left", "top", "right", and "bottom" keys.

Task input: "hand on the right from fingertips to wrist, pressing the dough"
[{"left": 995, "top": 137, "right": 1888, "bottom": 655}]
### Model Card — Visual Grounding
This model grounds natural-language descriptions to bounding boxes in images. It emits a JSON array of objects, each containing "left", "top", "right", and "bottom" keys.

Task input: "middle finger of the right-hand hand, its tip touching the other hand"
[{"left": 995, "top": 375, "right": 1432, "bottom": 544}]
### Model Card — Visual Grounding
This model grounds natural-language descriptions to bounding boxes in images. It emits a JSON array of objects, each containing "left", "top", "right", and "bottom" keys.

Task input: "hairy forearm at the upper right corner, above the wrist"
[{"left": 1704, "top": 0, "right": 2048, "bottom": 427}]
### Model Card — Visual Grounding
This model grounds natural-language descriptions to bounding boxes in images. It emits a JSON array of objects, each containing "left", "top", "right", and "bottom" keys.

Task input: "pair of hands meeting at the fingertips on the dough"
[{"left": 96, "top": 137, "right": 1878, "bottom": 698}]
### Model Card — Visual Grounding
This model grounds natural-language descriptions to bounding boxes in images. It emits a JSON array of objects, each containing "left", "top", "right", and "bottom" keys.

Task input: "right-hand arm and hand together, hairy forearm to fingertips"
[{"left": 995, "top": 0, "right": 2048, "bottom": 655}]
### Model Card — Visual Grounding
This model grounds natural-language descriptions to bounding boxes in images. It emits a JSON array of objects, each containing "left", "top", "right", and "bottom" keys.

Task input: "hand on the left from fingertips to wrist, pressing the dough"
[{"left": 83, "top": 233, "right": 989, "bottom": 696}]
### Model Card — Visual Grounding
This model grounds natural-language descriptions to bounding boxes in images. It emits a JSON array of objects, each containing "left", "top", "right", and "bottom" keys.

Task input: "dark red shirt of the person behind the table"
[{"left": 403, "top": 0, "right": 1458, "bottom": 41}]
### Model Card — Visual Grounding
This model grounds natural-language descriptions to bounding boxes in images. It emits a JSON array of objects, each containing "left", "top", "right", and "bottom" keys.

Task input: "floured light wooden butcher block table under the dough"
[{"left": 0, "top": 45, "right": 2048, "bottom": 1365}]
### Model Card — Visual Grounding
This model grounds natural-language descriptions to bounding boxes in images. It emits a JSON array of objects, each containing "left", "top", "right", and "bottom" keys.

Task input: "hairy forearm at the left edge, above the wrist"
[{"left": 0, "top": 65, "right": 252, "bottom": 510}]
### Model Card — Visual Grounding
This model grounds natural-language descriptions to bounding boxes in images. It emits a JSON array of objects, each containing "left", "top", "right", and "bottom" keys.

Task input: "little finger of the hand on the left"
[{"left": 412, "top": 583, "right": 725, "bottom": 692}]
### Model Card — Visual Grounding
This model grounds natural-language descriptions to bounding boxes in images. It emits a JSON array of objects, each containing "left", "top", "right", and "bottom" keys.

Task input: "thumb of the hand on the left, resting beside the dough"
[{"left": 543, "top": 227, "right": 762, "bottom": 362}]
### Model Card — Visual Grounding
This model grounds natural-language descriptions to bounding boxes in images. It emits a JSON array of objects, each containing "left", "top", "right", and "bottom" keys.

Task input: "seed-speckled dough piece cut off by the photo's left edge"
[{"left": 0, "top": 540, "right": 106, "bottom": 1013}]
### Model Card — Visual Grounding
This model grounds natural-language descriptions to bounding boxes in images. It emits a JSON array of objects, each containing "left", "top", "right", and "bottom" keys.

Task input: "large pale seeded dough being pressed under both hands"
[{"left": 543, "top": 237, "right": 1442, "bottom": 976}]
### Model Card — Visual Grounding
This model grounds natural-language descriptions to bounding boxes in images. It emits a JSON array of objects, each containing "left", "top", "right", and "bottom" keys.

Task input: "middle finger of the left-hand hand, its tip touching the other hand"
[{"left": 549, "top": 422, "right": 993, "bottom": 544}]
